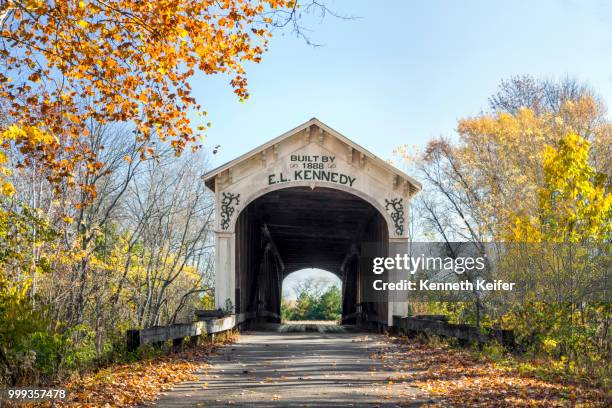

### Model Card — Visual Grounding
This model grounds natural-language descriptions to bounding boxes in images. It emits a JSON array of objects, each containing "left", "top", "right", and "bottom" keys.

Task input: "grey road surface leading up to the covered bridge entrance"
[{"left": 148, "top": 325, "right": 428, "bottom": 408}]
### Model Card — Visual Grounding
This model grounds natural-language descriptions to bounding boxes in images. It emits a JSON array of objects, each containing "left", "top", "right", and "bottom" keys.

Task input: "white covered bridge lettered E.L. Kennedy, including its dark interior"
[{"left": 204, "top": 119, "right": 421, "bottom": 327}]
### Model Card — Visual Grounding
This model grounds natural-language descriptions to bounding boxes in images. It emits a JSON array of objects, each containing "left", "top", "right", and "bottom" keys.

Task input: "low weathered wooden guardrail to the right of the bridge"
[{"left": 393, "top": 315, "right": 515, "bottom": 348}]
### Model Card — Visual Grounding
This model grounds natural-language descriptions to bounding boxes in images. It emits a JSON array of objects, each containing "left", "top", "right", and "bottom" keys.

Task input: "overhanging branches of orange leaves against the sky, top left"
[{"left": 0, "top": 0, "right": 294, "bottom": 199}]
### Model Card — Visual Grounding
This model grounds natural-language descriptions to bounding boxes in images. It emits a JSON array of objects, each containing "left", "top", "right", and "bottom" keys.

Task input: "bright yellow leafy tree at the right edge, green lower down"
[{"left": 502, "top": 134, "right": 612, "bottom": 376}]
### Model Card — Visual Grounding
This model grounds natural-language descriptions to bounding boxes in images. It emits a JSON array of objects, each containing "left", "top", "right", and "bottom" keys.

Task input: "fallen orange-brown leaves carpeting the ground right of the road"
[{"left": 383, "top": 338, "right": 607, "bottom": 407}]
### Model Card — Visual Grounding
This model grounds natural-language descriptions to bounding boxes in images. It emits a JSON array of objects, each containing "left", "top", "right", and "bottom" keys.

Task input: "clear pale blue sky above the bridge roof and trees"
[{"left": 194, "top": 0, "right": 612, "bottom": 170}]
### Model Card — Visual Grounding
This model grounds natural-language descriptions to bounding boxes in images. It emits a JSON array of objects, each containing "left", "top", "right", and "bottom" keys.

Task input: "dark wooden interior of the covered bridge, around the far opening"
[{"left": 236, "top": 187, "right": 388, "bottom": 323}]
